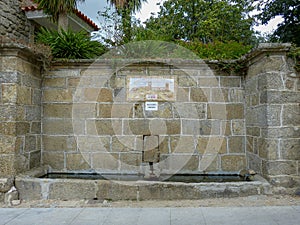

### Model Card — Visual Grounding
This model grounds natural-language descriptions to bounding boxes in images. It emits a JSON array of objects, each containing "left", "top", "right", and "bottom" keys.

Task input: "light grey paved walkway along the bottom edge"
[{"left": 0, "top": 206, "right": 300, "bottom": 225}]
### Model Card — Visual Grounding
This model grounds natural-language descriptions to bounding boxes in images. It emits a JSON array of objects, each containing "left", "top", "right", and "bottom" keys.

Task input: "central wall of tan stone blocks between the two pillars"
[{"left": 42, "top": 60, "right": 246, "bottom": 173}]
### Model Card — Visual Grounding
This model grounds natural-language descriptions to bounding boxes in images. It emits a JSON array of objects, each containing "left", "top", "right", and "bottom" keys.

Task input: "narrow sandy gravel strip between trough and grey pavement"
[{"left": 0, "top": 195, "right": 300, "bottom": 208}]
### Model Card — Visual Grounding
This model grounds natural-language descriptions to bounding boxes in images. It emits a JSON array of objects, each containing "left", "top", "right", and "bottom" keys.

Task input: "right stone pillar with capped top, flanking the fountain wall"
[{"left": 245, "top": 44, "right": 300, "bottom": 187}]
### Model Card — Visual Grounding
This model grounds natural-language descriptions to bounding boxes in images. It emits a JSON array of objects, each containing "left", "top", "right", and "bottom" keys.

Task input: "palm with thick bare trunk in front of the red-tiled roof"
[{"left": 33, "top": 0, "right": 84, "bottom": 30}]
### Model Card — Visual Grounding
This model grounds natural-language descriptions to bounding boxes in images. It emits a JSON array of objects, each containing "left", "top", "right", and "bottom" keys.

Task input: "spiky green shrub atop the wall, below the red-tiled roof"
[{"left": 37, "top": 28, "right": 106, "bottom": 59}]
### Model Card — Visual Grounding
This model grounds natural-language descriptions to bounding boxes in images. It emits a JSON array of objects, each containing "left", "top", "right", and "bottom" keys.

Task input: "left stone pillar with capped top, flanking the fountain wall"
[{"left": 0, "top": 43, "right": 41, "bottom": 181}]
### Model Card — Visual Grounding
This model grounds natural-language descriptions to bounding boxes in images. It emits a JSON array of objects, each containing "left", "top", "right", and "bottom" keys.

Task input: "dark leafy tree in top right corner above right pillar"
[{"left": 257, "top": 0, "right": 300, "bottom": 46}]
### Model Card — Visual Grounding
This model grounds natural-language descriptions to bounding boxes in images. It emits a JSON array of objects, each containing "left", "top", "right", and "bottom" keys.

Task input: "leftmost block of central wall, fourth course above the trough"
[{"left": 43, "top": 103, "right": 73, "bottom": 118}]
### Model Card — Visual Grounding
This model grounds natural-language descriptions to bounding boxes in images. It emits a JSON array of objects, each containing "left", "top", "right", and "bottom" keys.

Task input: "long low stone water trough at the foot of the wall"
[{"left": 15, "top": 166, "right": 271, "bottom": 201}]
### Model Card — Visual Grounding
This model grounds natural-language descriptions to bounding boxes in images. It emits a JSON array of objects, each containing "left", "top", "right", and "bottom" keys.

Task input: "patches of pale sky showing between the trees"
[{"left": 78, "top": 0, "right": 282, "bottom": 33}]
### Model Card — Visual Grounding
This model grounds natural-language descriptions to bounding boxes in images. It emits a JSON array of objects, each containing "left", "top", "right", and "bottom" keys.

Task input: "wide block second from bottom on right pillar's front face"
[{"left": 262, "top": 160, "right": 298, "bottom": 175}]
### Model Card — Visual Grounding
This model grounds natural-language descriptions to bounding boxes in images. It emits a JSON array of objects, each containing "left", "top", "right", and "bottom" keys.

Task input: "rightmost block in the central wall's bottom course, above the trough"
[{"left": 221, "top": 155, "right": 246, "bottom": 172}]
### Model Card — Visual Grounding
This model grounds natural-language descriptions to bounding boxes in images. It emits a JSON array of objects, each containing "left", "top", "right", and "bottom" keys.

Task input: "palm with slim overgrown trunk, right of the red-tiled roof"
[{"left": 107, "top": 0, "right": 147, "bottom": 43}]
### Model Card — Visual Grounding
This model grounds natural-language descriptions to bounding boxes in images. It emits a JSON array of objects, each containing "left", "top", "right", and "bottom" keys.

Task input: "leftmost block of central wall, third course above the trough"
[{"left": 42, "top": 119, "right": 74, "bottom": 135}]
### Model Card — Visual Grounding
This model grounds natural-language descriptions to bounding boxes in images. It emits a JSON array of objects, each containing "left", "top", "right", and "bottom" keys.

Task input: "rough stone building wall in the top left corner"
[{"left": 0, "top": 0, "right": 34, "bottom": 43}]
